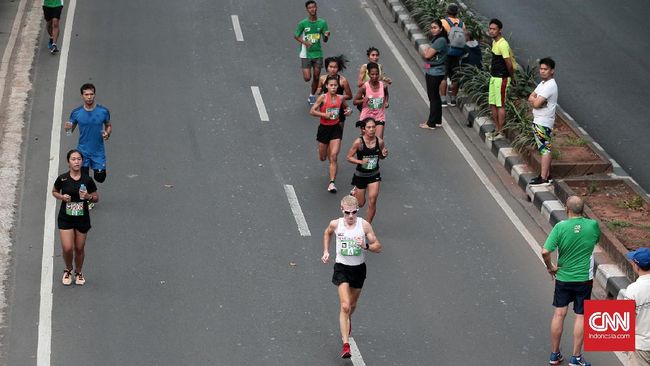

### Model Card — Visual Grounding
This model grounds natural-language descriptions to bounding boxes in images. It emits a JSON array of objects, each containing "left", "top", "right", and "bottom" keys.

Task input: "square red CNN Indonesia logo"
[{"left": 584, "top": 300, "right": 636, "bottom": 351}]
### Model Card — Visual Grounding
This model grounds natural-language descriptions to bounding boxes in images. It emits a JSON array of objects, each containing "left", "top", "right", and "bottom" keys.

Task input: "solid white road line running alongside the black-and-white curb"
[{"left": 365, "top": 4, "right": 543, "bottom": 262}]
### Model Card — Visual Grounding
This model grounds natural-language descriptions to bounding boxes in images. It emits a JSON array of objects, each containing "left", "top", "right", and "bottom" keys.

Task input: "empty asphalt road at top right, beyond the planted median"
[{"left": 466, "top": 0, "right": 650, "bottom": 191}]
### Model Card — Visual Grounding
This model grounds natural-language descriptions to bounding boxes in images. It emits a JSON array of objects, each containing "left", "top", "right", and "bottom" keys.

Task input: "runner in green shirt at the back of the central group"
[{"left": 293, "top": 0, "right": 330, "bottom": 105}]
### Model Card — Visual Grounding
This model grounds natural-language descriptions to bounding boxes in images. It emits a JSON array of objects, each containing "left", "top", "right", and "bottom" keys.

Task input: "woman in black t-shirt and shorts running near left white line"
[{"left": 52, "top": 150, "right": 99, "bottom": 286}]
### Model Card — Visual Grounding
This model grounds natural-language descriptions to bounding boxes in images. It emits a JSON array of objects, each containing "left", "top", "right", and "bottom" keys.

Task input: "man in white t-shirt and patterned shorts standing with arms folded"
[{"left": 528, "top": 57, "right": 557, "bottom": 185}]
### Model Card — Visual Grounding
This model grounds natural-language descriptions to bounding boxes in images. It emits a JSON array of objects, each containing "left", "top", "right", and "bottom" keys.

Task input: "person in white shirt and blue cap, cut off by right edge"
[{"left": 619, "top": 248, "right": 650, "bottom": 366}]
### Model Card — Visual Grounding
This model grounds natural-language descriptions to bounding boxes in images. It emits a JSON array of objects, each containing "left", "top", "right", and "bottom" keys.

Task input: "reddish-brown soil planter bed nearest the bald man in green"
[{"left": 553, "top": 176, "right": 650, "bottom": 281}]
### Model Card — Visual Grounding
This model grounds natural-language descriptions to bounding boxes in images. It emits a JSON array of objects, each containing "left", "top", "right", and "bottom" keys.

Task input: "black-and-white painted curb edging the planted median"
[{"left": 383, "top": 0, "right": 632, "bottom": 299}]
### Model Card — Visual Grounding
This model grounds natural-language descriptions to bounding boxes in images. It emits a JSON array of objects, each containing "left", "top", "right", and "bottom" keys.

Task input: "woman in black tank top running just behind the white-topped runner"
[{"left": 347, "top": 117, "right": 388, "bottom": 223}]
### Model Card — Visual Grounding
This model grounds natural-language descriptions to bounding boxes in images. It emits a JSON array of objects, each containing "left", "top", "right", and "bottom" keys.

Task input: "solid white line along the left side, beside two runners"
[{"left": 36, "top": 0, "right": 77, "bottom": 366}]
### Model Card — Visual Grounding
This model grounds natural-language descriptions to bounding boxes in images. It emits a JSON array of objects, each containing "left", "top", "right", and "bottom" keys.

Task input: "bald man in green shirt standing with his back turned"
[{"left": 542, "top": 196, "right": 600, "bottom": 365}]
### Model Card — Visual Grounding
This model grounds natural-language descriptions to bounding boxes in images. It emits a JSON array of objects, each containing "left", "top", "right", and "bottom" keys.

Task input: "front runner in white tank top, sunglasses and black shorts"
[{"left": 321, "top": 196, "right": 382, "bottom": 358}]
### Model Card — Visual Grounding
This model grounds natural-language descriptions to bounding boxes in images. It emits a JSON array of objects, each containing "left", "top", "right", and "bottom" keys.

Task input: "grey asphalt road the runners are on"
[{"left": 5, "top": 0, "right": 616, "bottom": 365}]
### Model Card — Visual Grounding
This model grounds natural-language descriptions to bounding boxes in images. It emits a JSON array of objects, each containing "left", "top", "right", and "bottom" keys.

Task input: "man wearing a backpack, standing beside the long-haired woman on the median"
[{"left": 440, "top": 3, "right": 466, "bottom": 107}]
